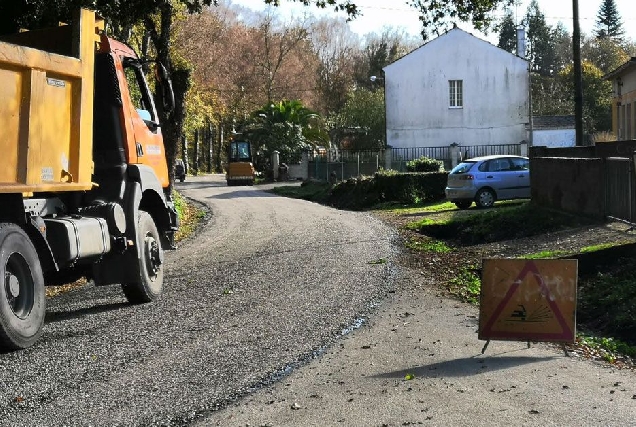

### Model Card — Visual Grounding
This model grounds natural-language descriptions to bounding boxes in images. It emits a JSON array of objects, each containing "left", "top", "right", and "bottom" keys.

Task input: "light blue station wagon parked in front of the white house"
[{"left": 446, "top": 156, "right": 530, "bottom": 209}]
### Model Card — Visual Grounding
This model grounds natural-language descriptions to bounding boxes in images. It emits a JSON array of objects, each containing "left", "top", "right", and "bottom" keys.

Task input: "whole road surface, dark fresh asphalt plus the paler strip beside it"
[{"left": 0, "top": 175, "right": 636, "bottom": 426}]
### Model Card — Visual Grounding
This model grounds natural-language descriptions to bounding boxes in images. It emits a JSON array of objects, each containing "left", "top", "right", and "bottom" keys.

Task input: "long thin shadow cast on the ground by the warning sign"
[{"left": 374, "top": 356, "right": 554, "bottom": 378}]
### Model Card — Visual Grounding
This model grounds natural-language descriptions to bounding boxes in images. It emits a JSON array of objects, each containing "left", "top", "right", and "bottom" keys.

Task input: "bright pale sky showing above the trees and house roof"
[{"left": 231, "top": 0, "right": 636, "bottom": 43}]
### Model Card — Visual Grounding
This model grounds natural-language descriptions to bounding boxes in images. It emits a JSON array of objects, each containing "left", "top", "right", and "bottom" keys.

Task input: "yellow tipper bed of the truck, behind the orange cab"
[{"left": 0, "top": 10, "right": 99, "bottom": 194}]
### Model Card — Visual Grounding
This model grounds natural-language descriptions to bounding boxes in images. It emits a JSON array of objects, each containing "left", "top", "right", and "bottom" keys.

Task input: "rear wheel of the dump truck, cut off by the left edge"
[{"left": 0, "top": 223, "right": 46, "bottom": 351}]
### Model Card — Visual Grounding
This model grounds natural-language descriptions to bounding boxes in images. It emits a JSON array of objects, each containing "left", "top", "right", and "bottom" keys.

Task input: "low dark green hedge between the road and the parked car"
[{"left": 328, "top": 171, "right": 448, "bottom": 210}]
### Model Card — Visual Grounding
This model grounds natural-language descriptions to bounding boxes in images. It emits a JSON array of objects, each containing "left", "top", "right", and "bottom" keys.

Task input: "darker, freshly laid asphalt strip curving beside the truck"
[{"left": 0, "top": 175, "right": 395, "bottom": 426}]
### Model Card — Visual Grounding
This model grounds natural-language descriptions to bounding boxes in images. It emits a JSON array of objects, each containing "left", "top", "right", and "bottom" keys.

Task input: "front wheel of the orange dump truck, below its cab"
[{"left": 122, "top": 211, "right": 163, "bottom": 304}]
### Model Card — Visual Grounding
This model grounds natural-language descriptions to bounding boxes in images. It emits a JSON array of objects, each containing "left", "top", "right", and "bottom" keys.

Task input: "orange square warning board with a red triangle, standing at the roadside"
[{"left": 479, "top": 259, "right": 578, "bottom": 342}]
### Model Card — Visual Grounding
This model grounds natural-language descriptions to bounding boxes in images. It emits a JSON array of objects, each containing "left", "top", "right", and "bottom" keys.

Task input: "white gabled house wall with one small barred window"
[{"left": 384, "top": 28, "right": 530, "bottom": 148}]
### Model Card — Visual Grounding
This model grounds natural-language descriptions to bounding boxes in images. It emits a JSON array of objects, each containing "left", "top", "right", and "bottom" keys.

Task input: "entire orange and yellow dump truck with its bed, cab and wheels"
[{"left": 0, "top": 10, "right": 178, "bottom": 350}]
